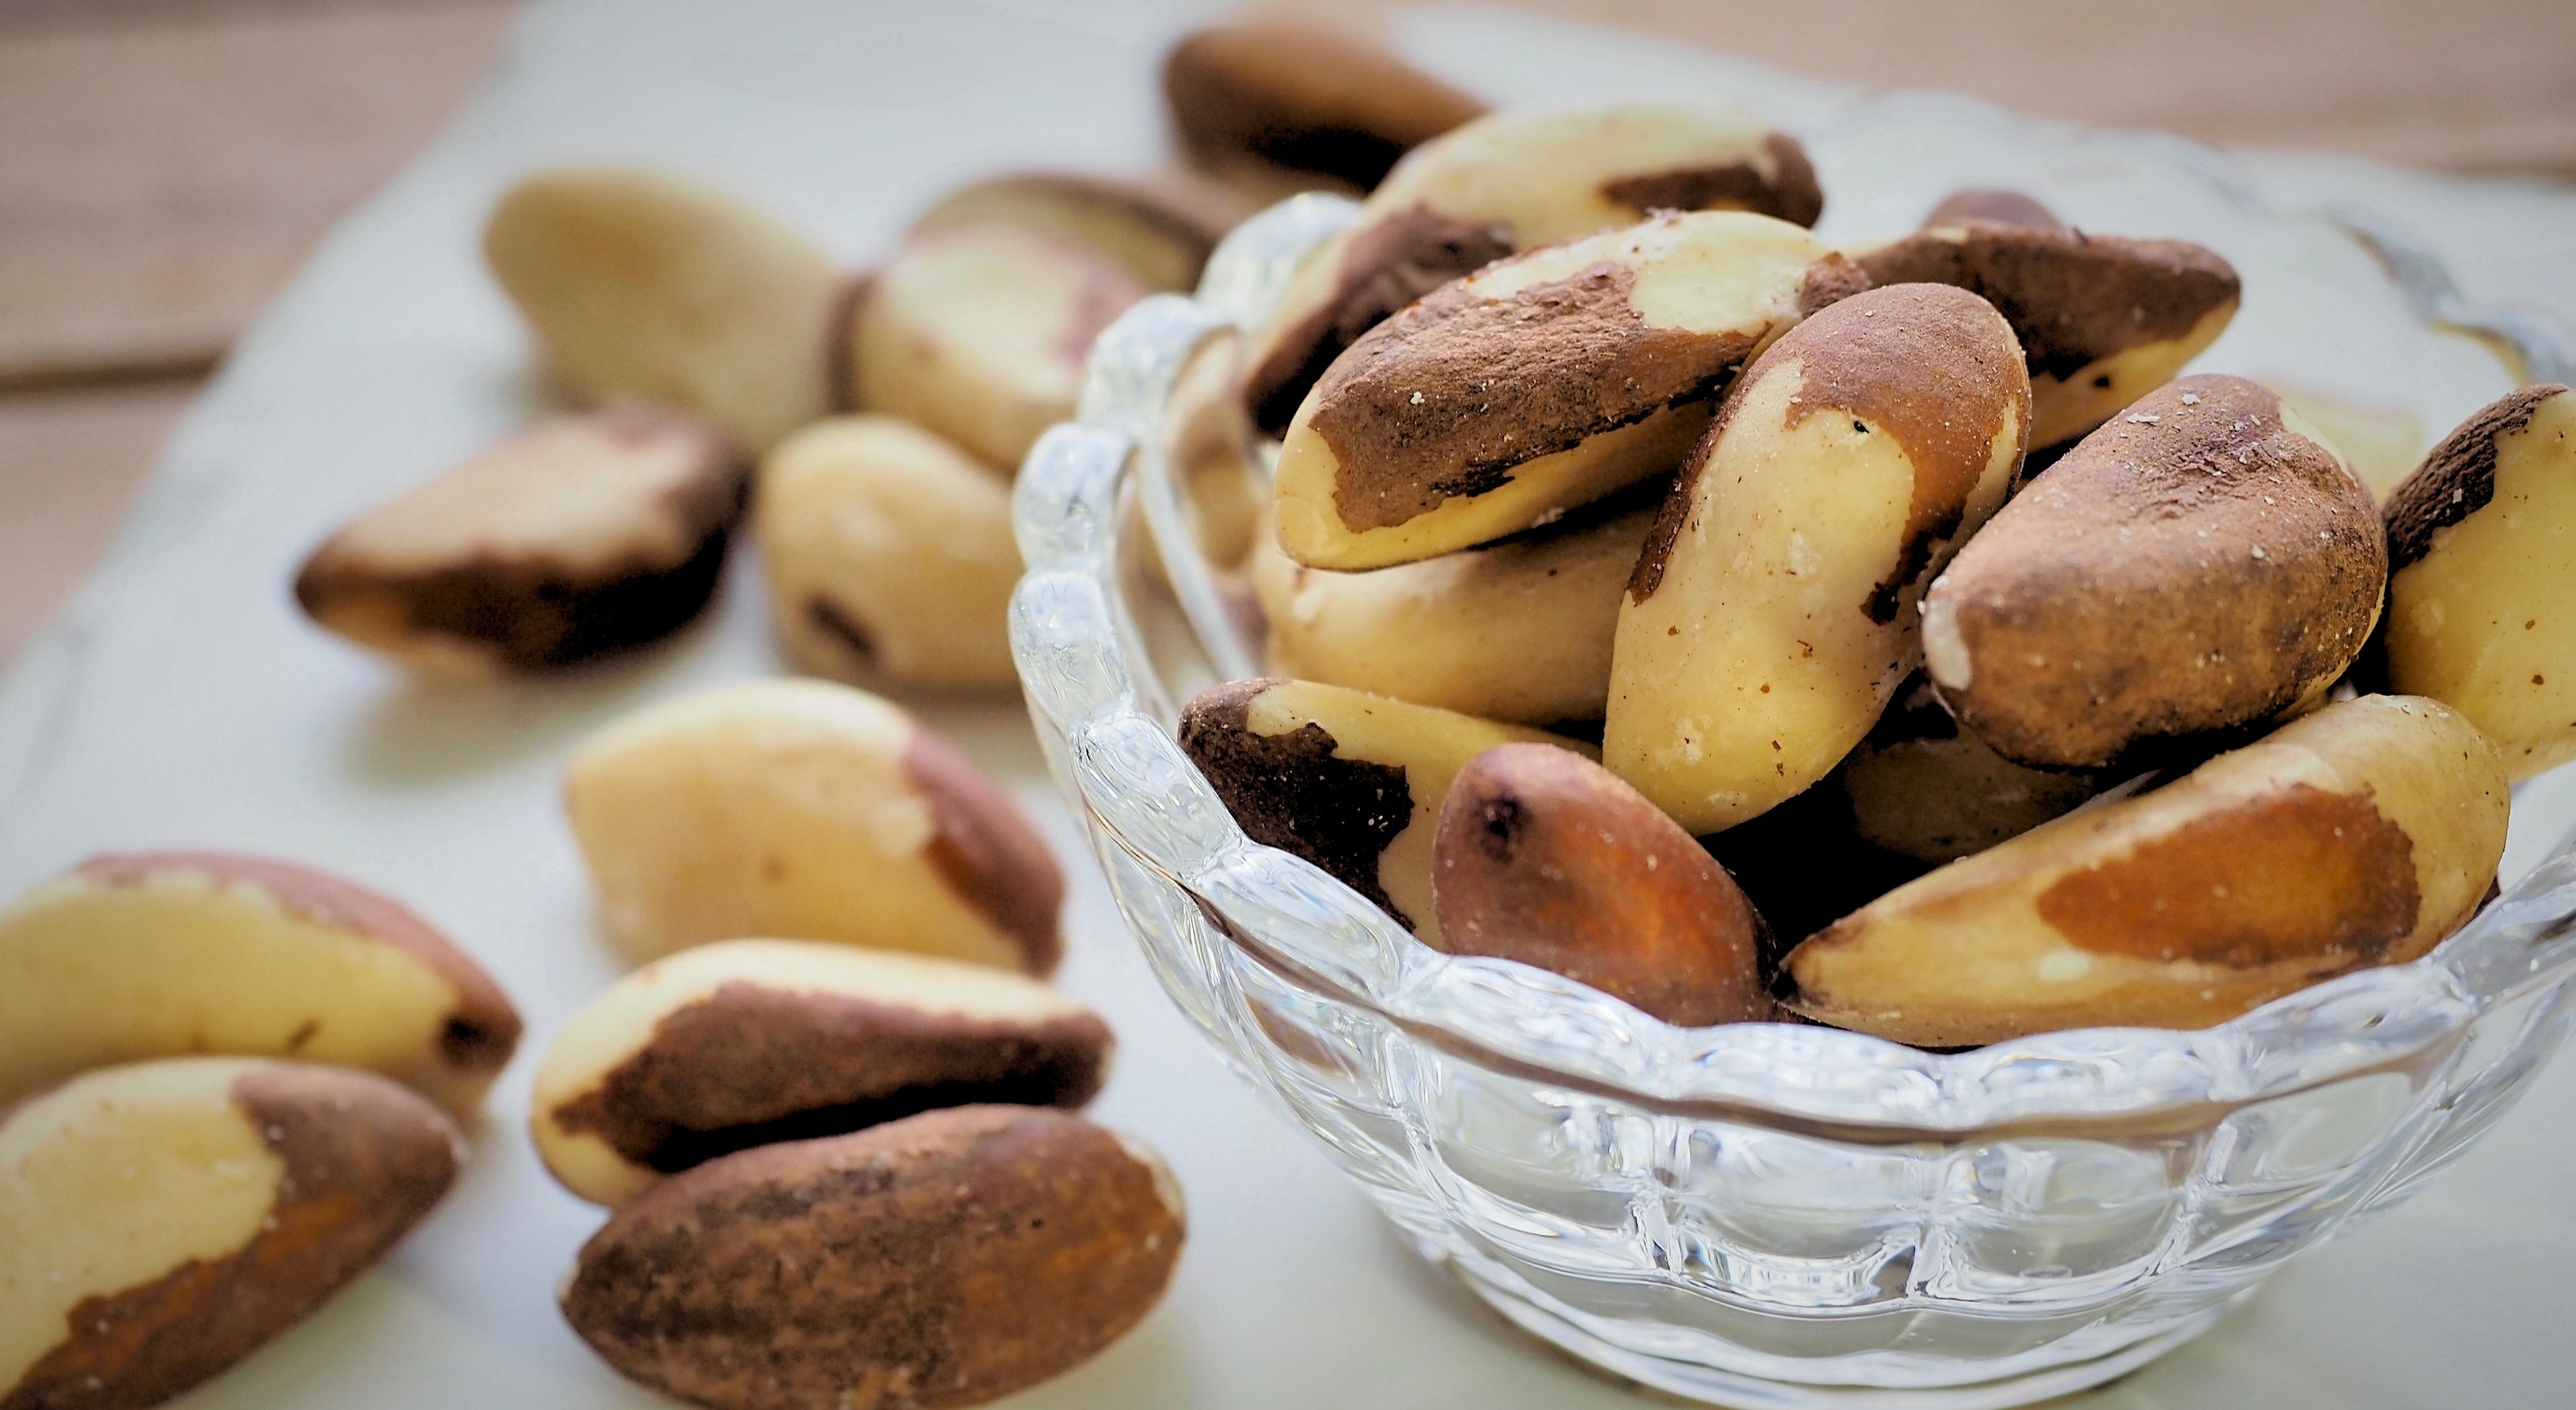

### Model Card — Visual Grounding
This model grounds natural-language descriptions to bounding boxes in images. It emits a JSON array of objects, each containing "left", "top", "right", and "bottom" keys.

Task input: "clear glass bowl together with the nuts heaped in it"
[{"left": 1012, "top": 100, "right": 2576, "bottom": 1407}]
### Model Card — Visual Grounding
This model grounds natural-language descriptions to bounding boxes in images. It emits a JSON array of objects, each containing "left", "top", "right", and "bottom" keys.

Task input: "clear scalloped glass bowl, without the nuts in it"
[{"left": 1012, "top": 98, "right": 2576, "bottom": 1407}]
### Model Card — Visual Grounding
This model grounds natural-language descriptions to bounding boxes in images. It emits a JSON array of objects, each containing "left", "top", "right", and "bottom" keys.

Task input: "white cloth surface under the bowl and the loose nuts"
[{"left": 0, "top": 0, "right": 2576, "bottom": 1410}]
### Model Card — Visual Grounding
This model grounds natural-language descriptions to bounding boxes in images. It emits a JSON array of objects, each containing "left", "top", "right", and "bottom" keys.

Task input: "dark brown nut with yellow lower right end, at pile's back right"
[{"left": 1852, "top": 207, "right": 2244, "bottom": 451}]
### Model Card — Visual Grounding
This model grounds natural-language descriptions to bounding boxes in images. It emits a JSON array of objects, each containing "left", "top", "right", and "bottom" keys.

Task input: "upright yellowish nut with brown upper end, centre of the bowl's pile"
[{"left": 1603, "top": 283, "right": 2030, "bottom": 832}]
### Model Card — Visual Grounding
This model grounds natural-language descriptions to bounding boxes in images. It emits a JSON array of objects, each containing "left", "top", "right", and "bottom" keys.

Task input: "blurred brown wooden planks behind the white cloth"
[{"left": 0, "top": 0, "right": 2576, "bottom": 660}]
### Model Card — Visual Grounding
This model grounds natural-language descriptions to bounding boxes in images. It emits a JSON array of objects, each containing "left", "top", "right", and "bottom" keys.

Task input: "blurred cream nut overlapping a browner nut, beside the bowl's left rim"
[{"left": 832, "top": 222, "right": 1146, "bottom": 472}]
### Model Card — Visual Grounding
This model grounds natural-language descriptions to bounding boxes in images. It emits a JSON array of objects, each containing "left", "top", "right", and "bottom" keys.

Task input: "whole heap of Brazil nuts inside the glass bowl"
[{"left": 1180, "top": 106, "right": 2576, "bottom": 1049}]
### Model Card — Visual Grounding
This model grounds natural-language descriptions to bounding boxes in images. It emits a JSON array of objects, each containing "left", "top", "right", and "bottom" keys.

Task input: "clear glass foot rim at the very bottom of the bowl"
[{"left": 1427, "top": 1250, "right": 2251, "bottom": 1410}]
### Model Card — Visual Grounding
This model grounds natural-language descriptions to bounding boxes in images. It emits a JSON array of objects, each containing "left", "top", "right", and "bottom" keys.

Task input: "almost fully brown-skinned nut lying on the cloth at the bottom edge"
[{"left": 564, "top": 1106, "right": 1185, "bottom": 1410}]
